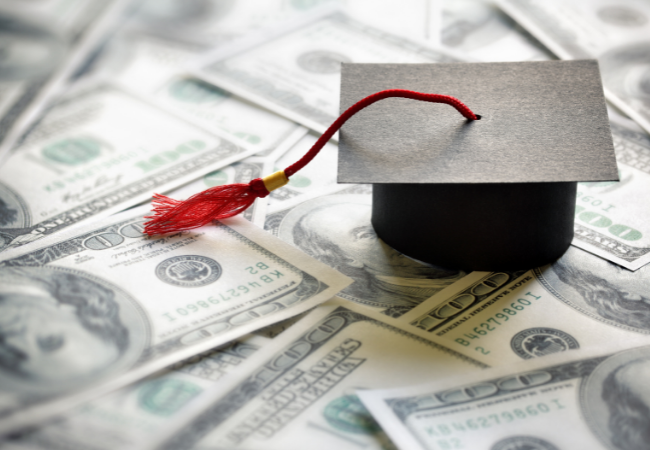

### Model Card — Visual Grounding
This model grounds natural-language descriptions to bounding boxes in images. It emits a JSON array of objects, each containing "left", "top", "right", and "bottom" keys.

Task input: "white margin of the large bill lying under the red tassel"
[{"left": 0, "top": 205, "right": 352, "bottom": 435}]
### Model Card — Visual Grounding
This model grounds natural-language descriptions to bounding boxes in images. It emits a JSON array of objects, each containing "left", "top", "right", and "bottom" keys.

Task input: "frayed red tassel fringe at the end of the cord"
[{"left": 144, "top": 178, "right": 269, "bottom": 236}]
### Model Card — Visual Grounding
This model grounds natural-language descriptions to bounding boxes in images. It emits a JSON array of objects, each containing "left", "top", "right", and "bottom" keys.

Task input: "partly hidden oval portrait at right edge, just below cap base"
[{"left": 537, "top": 246, "right": 650, "bottom": 333}]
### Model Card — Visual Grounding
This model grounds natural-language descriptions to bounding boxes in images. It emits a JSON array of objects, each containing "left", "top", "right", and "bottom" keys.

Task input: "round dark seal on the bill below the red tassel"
[{"left": 156, "top": 255, "right": 221, "bottom": 287}]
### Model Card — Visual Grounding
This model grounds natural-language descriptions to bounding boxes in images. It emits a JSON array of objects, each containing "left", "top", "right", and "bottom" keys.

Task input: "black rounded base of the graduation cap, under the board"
[{"left": 372, "top": 182, "right": 577, "bottom": 271}]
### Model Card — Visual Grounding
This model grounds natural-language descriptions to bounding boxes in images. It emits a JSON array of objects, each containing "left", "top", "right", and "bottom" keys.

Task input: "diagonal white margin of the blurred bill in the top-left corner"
[{"left": 0, "top": 0, "right": 132, "bottom": 166}]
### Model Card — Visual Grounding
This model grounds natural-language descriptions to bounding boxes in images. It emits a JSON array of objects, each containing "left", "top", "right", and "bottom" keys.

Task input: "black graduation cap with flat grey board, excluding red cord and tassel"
[{"left": 338, "top": 60, "right": 618, "bottom": 270}]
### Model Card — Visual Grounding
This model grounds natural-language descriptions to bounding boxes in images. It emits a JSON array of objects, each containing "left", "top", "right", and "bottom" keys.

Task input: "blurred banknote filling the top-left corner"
[{"left": 0, "top": 0, "right": 129, "bottom": 164}]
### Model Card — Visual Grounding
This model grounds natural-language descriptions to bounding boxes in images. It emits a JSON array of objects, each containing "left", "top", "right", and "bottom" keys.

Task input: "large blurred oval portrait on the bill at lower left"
[{"left": 0, "top": 267, "right": 148, "bottom": 391}]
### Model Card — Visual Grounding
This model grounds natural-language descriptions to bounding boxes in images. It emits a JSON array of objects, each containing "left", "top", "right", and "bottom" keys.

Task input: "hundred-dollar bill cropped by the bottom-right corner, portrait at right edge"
[{"left": 358, "top": 347, "right": 650, "bottom": 450}]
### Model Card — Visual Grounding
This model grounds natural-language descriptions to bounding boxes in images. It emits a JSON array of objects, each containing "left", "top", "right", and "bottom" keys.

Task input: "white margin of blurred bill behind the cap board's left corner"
[{"left": 188, "top": 10, "right": 473, "bottom": 137}]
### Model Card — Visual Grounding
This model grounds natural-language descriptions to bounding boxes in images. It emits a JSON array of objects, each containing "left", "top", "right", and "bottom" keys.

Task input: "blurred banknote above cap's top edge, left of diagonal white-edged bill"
[{"left": 440, "top": 0, "right": 554, "bottom": 61}]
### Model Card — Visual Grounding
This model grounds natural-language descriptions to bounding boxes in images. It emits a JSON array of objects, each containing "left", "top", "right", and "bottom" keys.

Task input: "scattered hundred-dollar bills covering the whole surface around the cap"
[{"left": 0, "top": 0, "right": 650, "bottom": 450}]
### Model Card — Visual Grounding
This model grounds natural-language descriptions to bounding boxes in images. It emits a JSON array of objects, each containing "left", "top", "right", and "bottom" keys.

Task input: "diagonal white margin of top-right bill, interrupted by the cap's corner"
[{"left": 495, "top": 0, "right": 650, "bottom": 137}]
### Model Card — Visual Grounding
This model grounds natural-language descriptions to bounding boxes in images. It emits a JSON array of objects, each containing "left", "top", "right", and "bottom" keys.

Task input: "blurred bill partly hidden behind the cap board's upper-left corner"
[{"left": 198, "top": 13, "right": 459, "bottom": 133}]
